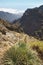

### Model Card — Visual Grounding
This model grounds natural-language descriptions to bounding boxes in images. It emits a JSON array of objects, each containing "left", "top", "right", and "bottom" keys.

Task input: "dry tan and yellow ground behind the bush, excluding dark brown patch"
[{"left": 0, "top": 31, "right": 43, "bottom": 65}]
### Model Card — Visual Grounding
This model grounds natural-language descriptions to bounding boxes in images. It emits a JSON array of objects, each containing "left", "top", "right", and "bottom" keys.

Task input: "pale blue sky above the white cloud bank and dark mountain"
[{"left": 0, "top": 0, "right": 43, "bottom": 10}]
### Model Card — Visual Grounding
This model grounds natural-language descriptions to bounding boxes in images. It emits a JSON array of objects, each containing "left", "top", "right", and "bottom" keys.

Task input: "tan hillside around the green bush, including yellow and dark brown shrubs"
[{"left": 0, "top": 31, "right": 43, "bottom": 65}]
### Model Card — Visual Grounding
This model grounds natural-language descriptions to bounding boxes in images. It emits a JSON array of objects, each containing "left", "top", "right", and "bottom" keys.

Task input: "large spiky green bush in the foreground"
[{"left": 4, "top": 43, "right": 42, "bottom": 65}]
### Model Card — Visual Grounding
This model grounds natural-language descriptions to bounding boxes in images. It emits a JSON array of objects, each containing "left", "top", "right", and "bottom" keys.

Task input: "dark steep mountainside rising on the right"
[{"left": 20, "top": 6, "right": 43, "bottom": 39}]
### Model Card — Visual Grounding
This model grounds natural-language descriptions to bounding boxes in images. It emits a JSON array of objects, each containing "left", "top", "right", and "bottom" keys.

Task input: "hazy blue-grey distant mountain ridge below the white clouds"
[{"left": 0, "top": 11, "right": 22, "bottom": 22}]
